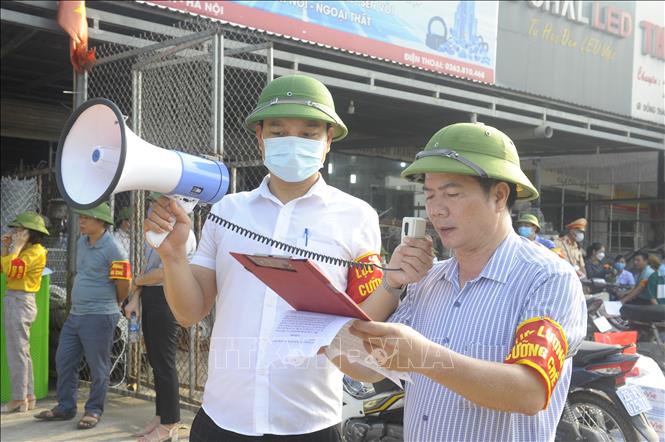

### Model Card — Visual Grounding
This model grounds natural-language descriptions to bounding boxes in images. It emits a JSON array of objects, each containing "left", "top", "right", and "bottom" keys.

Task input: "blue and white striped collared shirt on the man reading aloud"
[{"left": 389, "top": 232, "right": 586, "bottom": 442}]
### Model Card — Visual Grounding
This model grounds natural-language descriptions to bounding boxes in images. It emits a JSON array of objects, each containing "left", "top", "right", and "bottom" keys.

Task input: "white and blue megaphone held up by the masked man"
[{"left": 55, "top": 98, "right": 229, "bottom": 247}]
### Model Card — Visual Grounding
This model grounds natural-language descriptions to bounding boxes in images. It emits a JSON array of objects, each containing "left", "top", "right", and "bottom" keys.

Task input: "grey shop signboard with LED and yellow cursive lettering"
[{"left": 496, "top": 0, "right": 636, "bottom": 116}]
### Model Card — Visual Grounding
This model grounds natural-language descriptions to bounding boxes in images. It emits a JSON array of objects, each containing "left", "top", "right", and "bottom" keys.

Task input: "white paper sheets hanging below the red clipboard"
[{"left": 269, "top": 310, "right": 411, "bottom": 387}]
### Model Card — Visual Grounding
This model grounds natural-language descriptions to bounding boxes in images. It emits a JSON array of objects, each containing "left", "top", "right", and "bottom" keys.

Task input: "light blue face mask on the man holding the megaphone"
[{"left": 263, "top": 137, "right": 327, "bottom": 183}]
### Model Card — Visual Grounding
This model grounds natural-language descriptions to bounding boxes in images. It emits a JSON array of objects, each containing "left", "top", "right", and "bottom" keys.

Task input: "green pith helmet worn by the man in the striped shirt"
[{"left": 402, "top": 123, "right": 538, "bottom": 201}]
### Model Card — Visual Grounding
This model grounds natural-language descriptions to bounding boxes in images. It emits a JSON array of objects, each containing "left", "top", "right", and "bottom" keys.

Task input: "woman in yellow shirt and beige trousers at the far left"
[{"left": 0, "top": 212, "right": 49, "bottom": 413}]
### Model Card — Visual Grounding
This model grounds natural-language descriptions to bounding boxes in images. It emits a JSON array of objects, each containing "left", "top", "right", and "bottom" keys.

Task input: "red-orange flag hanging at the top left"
[{"left": 58, "top": 0, "right": 95, "bottom": 74}]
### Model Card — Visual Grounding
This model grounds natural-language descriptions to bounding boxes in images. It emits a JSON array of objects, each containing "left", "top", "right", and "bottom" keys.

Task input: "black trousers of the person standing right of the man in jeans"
[{"left": 141, "top": 286, "right": 180, "bottom": 425}]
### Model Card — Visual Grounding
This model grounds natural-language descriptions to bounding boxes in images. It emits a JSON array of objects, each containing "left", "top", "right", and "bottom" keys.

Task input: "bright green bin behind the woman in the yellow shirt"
[{"left": 0, "top": 273, "right": 51, "bottom": 402}]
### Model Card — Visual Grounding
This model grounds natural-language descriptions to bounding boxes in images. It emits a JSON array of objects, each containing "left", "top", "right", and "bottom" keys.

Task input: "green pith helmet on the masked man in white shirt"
[{"left": 245, "top": 75, "right": 349, "bottom": 141}]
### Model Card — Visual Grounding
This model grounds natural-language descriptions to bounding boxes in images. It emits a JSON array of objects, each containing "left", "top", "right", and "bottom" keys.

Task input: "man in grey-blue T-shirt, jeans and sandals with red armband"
[{"left": 35, "top": 203, "right": 131, "bottom": 430}]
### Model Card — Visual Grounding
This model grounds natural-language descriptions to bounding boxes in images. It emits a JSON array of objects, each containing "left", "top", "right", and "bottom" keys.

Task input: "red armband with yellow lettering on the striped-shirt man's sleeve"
[{"left": 504, "top": 317, "right": 568, "bottom": 409}]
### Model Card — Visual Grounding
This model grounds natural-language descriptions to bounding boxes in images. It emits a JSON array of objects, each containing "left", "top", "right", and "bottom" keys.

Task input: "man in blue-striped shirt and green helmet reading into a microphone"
[{"left": 335, "top": 123, "right": 586, "bottom": 441}]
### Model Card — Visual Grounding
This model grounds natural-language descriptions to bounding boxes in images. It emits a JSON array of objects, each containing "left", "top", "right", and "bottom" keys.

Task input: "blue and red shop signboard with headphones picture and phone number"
[{"left": 143, "top": 0, "right": 499, "bottom": 84}]
